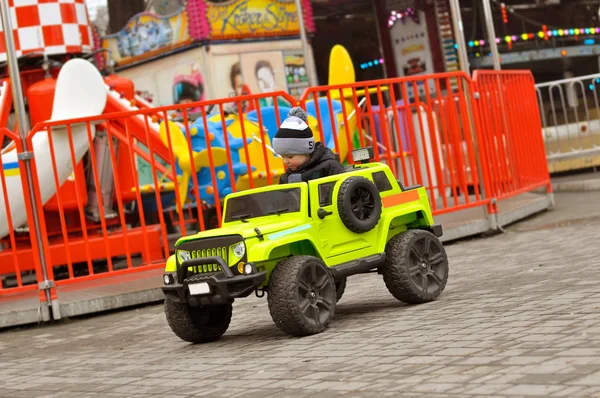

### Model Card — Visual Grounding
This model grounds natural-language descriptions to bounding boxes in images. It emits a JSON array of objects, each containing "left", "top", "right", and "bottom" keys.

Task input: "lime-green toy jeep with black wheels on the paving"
[{"left": 163, "top": 148, "right": 448, "bottom": 343}]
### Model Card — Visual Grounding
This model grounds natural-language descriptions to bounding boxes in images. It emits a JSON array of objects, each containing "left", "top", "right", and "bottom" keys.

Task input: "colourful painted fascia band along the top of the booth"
[{"left": 96, "top": 0, "right": 315, "bottom": 67}]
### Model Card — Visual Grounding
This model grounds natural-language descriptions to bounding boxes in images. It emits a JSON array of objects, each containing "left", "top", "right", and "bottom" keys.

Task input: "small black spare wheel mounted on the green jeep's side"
[{"left": 337, "top": 177, "right": 381, "bottom": 233}]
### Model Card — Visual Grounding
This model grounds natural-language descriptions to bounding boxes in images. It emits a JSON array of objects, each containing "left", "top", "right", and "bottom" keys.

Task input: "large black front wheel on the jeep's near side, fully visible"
[{"left": 267, "top": 256, "right": 336, "bottom": 336}]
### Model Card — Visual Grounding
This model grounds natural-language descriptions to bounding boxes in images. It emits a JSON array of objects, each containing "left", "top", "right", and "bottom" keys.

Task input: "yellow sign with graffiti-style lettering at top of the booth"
[{"left": 207, "top": 0, "right": 300, "bottom": 40}]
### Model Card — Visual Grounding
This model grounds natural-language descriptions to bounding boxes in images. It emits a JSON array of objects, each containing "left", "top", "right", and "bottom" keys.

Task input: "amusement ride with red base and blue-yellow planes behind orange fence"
[{"left": 0, "top": 0, "right": 372, "bottom": 280}]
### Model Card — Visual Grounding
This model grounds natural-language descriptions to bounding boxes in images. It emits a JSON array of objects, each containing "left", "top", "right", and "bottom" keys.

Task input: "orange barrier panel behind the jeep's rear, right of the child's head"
[{"left": 301, "top": 72, "right": 489, "bottom": 214}]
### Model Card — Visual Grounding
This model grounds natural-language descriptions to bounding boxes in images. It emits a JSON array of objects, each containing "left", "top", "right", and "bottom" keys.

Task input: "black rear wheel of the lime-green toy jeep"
[{"left": 381, "top": 229, "right": 448, "bottom": 304}]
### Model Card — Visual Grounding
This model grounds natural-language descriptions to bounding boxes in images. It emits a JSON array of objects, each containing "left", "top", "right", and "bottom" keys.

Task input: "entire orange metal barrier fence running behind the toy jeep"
[{"left": 0, "top": 68, "right": 550, "bottom": 318}]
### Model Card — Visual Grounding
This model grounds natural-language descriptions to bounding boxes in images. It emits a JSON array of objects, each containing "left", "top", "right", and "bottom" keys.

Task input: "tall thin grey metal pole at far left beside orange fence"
[{"left": 0, "top": 0, "right": 60, "bottom": 319}]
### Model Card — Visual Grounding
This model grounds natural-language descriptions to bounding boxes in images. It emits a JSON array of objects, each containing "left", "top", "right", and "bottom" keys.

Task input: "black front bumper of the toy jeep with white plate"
[{"left": 162, "top": 257, "right": 267, "bottom": 306}]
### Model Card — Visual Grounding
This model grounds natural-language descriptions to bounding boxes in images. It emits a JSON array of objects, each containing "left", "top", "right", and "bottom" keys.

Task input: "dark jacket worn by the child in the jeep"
[{"left": 279, "top": 142, "right": 345, "bottom": 184}]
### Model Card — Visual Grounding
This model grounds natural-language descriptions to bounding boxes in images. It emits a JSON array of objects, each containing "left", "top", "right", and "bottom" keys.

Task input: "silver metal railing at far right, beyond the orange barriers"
[{"left": 536, "top": 74, "right": 600, "bottom": 172}]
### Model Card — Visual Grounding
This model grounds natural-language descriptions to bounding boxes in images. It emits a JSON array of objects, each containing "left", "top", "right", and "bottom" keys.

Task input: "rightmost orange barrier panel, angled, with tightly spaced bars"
[{"left": 473, "top": 71, "right": 552, "bottom": 200}]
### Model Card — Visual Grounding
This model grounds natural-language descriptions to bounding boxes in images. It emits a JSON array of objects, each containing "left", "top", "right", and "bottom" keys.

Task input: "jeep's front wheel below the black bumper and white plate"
[{"left": 165, "top": 297, "right": 232, "bottom": 343}]
